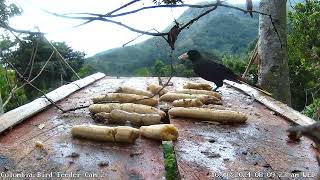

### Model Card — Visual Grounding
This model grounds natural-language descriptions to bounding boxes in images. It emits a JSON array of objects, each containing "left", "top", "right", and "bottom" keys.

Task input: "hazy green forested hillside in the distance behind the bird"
[{"left": 87, "top": 3, "right": 258, "bottom": 76}]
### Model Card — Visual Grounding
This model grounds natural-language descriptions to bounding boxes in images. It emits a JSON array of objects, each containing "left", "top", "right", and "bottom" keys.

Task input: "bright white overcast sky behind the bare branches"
[{"left": 10, "top": 0, "right": 245, "bottom": 56}]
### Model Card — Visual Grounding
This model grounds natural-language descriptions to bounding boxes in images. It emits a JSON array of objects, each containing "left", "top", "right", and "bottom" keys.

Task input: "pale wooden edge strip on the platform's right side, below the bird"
[{"left": 224, "top": 81, "right": 315, "bottom": 126}]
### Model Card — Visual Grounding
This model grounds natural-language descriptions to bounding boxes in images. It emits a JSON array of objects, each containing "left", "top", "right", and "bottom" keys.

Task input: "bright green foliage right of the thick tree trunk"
[{"left": 288, "top": 0, "right": 320, "bottom": 110}]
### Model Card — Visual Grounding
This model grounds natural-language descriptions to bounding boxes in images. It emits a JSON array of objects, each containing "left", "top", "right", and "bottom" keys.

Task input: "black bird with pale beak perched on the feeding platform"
[{"left": 179, "top": 50, "right": 243, "bottom": 91}]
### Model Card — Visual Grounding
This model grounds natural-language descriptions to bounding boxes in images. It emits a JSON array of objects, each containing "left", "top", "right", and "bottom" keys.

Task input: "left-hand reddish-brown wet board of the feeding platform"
[{"left": 0, "top": 77, "right": 165, "bottom": 179}]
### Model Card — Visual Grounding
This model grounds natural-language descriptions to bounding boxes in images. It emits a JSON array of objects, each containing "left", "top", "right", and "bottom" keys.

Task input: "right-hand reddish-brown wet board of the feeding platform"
[{"left": 170, "top": 78, "right": 318, "bottom": 179}]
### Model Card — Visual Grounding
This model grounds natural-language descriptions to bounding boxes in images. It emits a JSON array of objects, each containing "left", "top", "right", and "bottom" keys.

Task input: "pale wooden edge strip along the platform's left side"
[{"left": 0, "top": 73, "right": 105, "bottom": 134}]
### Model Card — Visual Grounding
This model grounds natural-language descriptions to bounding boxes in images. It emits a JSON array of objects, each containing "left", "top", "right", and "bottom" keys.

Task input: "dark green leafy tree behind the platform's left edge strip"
[{"left": 7, "top": 35, "right": 85, "bottom": 100}]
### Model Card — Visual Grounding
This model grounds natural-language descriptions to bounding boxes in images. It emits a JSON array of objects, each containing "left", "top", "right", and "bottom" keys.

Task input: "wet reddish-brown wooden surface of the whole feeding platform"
[{"left": 0, "top": 77, "right": 318, "bottom": 179}]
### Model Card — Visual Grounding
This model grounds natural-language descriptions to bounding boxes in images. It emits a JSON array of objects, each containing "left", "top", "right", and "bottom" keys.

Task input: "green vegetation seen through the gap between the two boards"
[{"left": 162, "top": 141, "right": 180, "bottom": 180}]
